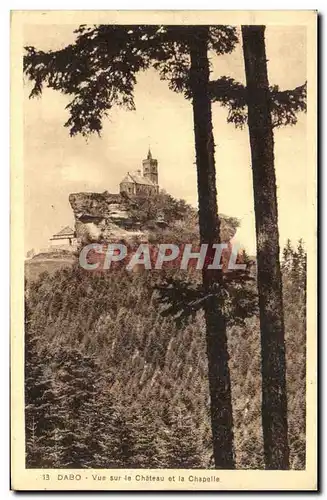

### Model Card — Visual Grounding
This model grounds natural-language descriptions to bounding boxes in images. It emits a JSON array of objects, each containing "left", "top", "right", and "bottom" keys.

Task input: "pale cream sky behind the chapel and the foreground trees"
[{"left": 24, "top": 25, "right": 307, "bottom": 254}]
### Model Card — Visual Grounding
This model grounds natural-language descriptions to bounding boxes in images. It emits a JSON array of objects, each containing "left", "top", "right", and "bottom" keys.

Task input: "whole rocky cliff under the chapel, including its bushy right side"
[{"left": 69, "top": 191, "right": 238, "bottom": 244}]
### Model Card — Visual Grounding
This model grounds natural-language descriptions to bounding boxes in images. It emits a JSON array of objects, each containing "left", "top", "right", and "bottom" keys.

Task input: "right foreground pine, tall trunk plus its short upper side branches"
[{"left": 210, "top": 26, "right": 306, "bottom": 468}]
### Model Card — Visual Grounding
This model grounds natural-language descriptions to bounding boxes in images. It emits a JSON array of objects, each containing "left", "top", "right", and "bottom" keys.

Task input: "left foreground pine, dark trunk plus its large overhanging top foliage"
[{"left": 24, "top": 25, "right": 237, "bottom": 469}]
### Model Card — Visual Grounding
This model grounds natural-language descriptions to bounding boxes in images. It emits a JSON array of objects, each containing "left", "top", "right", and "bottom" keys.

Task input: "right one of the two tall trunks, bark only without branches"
[{"left": 242, "top": 26, "right": 289, "bottom": 469}]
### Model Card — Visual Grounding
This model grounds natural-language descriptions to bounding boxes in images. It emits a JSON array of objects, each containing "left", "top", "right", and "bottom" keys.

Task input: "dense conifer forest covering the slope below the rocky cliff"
[{"left": 25, "top": 242, "right": 306, "bottom": 469}]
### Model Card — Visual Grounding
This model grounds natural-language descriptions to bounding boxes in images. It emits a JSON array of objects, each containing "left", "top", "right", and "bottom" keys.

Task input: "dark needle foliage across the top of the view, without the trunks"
[{"left": 24, "top": 25, "right": 306, "bottom": 135}]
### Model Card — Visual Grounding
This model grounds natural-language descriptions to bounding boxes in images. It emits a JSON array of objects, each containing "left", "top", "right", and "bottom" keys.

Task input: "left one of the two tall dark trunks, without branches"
[{"left": 190, "top": 26, "right": 235, "bottom": 469}]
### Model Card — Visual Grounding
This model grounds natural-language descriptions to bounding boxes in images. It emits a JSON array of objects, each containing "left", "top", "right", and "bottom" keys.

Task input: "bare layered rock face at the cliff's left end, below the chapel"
[{"left": 69, "top": 191, "right": 146, "bottom": 244}]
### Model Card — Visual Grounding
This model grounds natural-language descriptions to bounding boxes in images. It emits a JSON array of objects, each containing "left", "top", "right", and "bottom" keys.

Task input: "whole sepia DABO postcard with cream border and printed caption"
[{"left": 11, "top": 11, "right": 318, "bottom": 491}]
